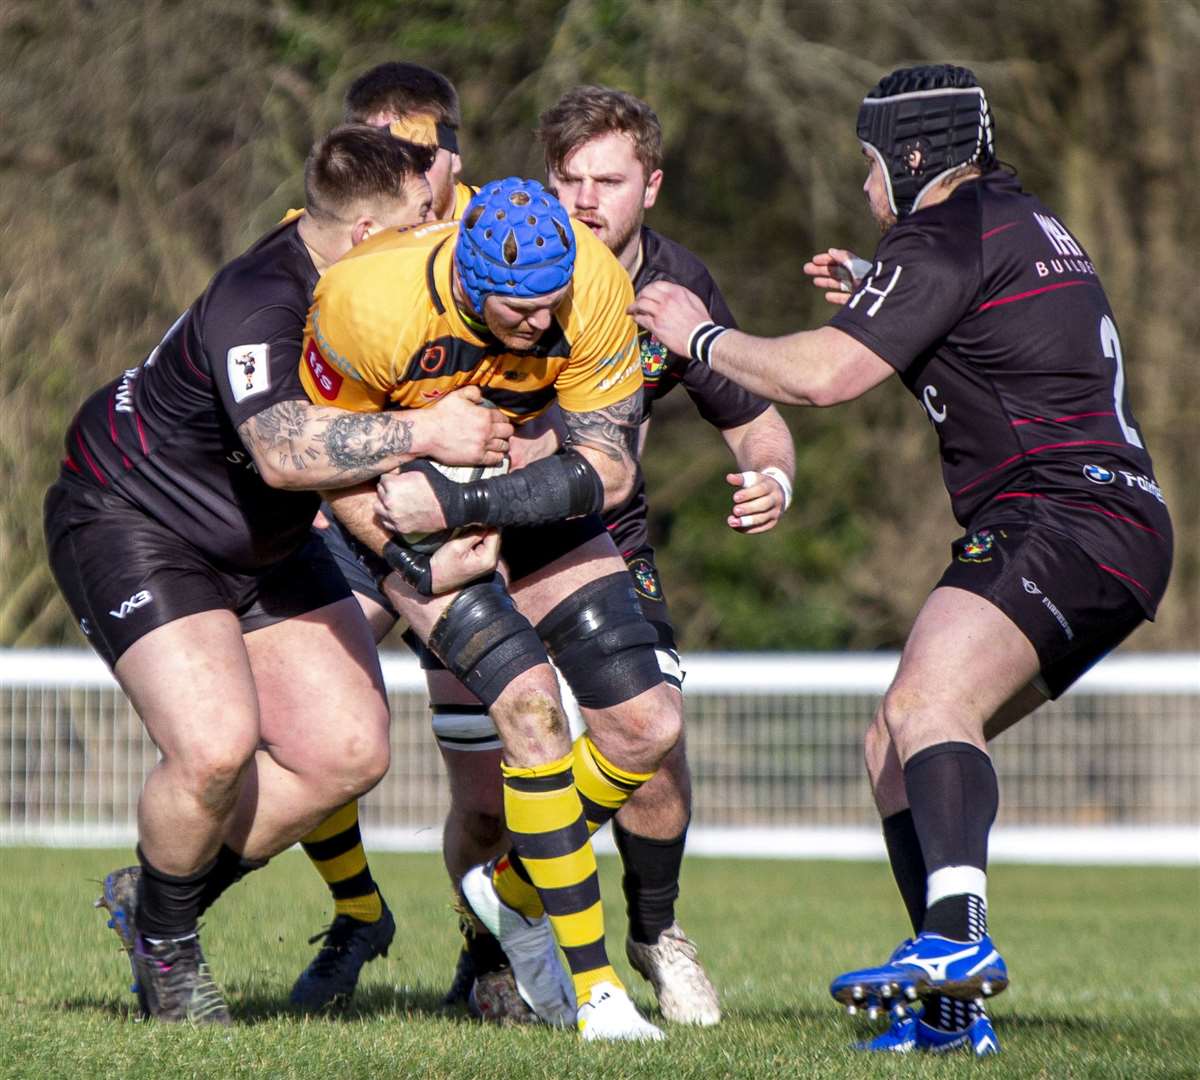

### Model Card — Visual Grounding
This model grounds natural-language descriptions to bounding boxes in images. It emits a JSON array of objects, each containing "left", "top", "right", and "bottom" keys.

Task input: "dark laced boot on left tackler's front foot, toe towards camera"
[{"left": 133, "top": 934, "right": 232, "bottom": 1025}]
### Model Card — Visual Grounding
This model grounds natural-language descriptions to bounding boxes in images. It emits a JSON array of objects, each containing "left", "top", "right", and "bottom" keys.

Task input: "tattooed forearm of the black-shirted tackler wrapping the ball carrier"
[{"left": 238, "top": 400, "right": 419, "bottom": 491}]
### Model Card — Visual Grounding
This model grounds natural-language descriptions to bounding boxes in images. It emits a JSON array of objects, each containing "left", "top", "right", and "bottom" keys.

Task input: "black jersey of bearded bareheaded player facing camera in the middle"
[{"left": 604, "top": 226, "right": 770, "bottom": 556}]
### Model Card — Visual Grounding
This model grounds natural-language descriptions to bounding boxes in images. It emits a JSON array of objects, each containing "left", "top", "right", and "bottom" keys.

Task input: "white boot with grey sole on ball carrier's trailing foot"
[{"left": 461, "top": 862, "right": 576, "bottom": 1027}]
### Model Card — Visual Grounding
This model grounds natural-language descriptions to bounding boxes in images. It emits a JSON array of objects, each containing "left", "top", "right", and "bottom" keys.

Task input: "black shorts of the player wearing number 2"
[{"left": 937, "top": 523, "right": 1146, "bottom": 700}]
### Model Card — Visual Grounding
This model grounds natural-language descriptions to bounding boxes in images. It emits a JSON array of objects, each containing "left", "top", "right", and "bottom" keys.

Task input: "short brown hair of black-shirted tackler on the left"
[{"left": 304, "top": 124, "right": 436, "bottom": 217}]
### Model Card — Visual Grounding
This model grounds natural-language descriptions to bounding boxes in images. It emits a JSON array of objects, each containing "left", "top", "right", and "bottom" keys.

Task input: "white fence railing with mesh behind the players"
[{"left": 0, "top": 650, "right": 1200, "bottom": 863}]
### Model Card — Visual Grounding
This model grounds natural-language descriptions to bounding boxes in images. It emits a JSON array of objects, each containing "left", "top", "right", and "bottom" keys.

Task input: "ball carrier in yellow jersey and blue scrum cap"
[{"left": 300, "top": 179, "right": 679, "bottom": 1038}]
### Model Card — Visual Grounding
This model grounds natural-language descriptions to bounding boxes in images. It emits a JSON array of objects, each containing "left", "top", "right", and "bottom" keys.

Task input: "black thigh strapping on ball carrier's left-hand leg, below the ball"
[{"left": 430, "top": 575, "right": 546, "bottom": 709}]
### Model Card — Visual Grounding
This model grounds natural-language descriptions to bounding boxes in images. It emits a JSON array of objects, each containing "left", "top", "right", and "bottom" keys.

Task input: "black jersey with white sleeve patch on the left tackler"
[{"left": 62, "top": 218, "right": 320, "bottom": 571}]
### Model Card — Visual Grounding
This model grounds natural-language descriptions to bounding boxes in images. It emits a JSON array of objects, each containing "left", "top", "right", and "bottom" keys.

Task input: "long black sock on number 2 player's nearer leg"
[{"left": 904, "top": 743, "right": 1000, "bottom": 941}]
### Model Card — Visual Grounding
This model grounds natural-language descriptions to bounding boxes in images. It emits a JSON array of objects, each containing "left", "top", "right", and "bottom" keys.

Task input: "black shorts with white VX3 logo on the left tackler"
[{"left": 44, "top": 480, "right": 350, "bottom": 667}]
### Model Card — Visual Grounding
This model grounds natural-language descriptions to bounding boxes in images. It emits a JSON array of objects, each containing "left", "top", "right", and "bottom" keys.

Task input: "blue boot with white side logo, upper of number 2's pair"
[{"left": 829, "top": 934, "right": 1008, "bottom": 1015}]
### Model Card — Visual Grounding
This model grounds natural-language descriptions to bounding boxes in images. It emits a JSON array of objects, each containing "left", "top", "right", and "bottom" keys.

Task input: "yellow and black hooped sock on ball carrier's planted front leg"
[{"left": 500, "top": 754, "right": 622, "bottom": 1004}]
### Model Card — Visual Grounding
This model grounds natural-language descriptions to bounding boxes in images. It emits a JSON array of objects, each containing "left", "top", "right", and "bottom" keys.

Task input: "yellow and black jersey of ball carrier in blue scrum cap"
[{"left": 300, "top": 221, "right": 642, "bottom": 424}]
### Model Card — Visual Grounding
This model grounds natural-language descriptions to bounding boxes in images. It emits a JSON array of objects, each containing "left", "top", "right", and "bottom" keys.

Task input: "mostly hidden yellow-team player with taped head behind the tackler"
[{"left": 290, "top": 62, "right": 536, "bottom": 1022}]
